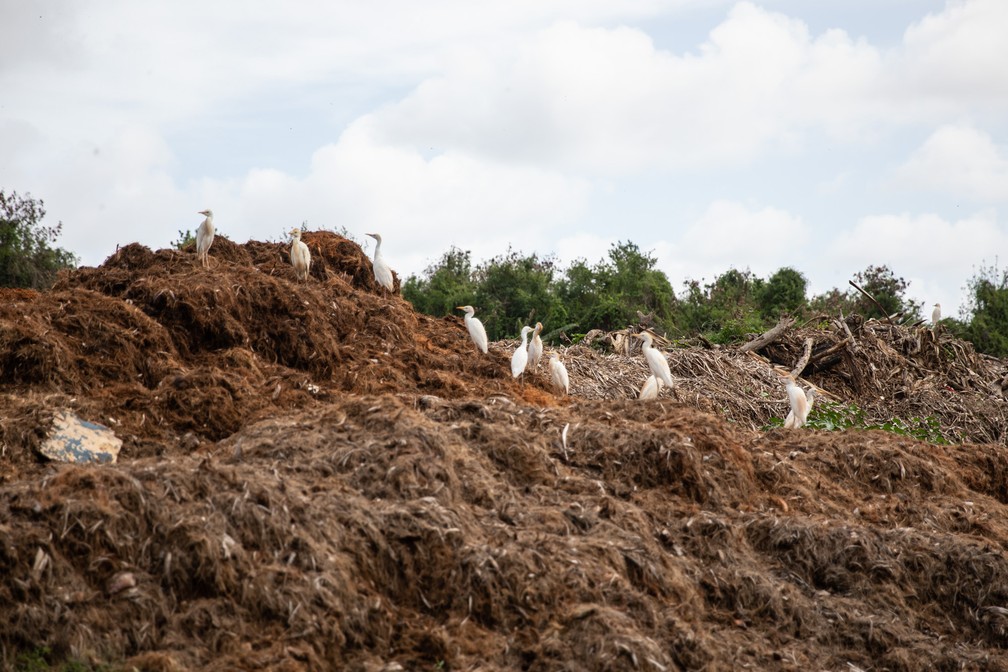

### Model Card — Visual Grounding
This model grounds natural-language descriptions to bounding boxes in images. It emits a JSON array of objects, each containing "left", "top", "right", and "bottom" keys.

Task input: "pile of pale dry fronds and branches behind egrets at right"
[{"left": 562, "top": 316, "right": 1008, "bottom": 443}]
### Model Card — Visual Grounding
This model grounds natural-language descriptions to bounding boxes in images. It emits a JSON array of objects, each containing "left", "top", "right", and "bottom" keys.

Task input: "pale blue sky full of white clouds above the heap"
[{"left": 0, "top": 0, "right": 1008, "bottom": 315}]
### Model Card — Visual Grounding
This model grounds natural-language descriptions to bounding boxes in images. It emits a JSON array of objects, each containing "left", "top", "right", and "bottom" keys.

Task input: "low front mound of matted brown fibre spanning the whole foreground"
[{"left": 0, "top": 396, "right": 1008, "bottom": 670}]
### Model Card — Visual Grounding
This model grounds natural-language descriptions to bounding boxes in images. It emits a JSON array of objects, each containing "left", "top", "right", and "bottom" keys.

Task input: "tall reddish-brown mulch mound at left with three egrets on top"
[{"left": 0, "top": 232, "right": 554, "bottom": 481}]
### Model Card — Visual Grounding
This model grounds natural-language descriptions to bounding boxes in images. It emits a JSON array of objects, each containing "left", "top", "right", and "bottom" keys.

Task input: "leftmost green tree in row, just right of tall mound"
[{"left": 402, "top": 246, "right": 475, "bottom": 323}]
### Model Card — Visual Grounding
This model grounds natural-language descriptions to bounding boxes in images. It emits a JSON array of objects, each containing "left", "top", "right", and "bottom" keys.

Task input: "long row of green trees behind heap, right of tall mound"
[{"left": 402, "top": 241, "right": 951, "bottom": 343}]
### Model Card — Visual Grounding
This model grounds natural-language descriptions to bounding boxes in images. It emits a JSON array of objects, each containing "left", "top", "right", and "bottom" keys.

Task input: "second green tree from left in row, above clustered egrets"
[{"left": 473, "top": 250, "right": 568, "bottom": 341}]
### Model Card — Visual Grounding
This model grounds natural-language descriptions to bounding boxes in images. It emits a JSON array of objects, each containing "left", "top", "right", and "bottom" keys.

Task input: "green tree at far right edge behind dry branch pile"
[{"left": 962, "top": 265, "right": 1008, "bottom": 358}]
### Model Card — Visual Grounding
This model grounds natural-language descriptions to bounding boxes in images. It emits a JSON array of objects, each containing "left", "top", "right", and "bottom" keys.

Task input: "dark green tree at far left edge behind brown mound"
[{"left": 0, "top": 190, "right": 78, "bottom": 289}]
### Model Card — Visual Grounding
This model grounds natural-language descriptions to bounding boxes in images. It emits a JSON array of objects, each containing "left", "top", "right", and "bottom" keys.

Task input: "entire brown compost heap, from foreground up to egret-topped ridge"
[{"left": 0, "top": 233, "right": 1008, "bottom": 671}]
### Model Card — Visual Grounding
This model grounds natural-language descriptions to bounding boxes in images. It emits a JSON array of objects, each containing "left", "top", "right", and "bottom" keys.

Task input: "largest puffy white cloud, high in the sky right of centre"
[{"left": 377, "top": 2, "right": 880, "bottom": 174}]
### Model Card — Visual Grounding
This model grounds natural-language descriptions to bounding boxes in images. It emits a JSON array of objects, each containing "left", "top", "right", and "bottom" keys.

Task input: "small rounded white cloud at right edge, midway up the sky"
[{"left": 896, "top": 125, "right": 1008, "bottom": 203}]
